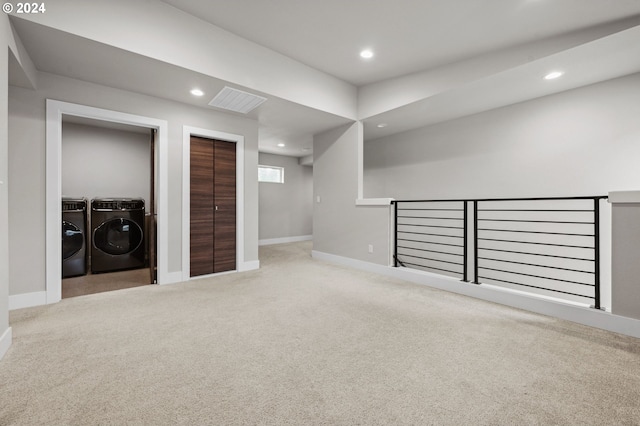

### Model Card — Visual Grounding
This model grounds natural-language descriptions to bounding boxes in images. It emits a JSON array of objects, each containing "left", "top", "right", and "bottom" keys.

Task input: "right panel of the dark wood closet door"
[{"left": 213, "top": 141, "right": 236, "bottom": 272}]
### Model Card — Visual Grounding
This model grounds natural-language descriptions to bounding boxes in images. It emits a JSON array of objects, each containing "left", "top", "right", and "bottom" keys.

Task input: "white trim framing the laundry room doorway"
[{"left": 46, "top": 99, "right": 169, "bottom": 303}]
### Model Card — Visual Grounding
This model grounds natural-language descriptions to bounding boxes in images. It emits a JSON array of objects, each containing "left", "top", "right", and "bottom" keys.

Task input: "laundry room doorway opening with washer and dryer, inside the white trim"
[{"left": 61, "top": 116, "right": 156, "bottom": 298}]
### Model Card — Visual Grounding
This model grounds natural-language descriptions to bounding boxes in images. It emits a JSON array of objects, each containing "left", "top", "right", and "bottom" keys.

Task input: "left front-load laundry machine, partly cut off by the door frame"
[{"left": 62, "top": 197, "right": 87, "bottom": 278}]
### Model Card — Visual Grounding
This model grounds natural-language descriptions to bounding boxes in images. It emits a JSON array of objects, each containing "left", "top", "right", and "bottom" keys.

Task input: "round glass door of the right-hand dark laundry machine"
[{"left": 93, "top": 218, "right": 143, "bottom": 256}]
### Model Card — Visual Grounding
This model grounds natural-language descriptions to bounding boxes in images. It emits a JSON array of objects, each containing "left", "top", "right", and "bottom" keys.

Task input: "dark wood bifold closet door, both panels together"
[{"left": 190, "top": 136, "right": 236, "bottom": 277}]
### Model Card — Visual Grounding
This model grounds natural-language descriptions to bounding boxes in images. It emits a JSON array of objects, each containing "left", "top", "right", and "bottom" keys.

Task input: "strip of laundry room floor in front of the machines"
[{"left": 62, "top": 268, "right": 150, "bottom": 299}]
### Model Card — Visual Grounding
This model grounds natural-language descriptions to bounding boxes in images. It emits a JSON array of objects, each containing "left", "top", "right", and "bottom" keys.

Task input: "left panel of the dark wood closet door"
[{"left": 190, "top": 136, "right": 214, "bottom": 277}]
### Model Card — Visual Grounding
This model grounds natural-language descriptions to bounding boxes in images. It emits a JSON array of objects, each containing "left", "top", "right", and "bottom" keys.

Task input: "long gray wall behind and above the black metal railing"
[{"left": 364, "top": 74, "right": 640, "bottom": 199}]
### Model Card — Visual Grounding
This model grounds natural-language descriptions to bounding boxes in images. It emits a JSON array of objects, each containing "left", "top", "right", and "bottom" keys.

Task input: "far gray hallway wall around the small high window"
[{"left": 258, "top": 153, "right": 313, "bottom": 241}]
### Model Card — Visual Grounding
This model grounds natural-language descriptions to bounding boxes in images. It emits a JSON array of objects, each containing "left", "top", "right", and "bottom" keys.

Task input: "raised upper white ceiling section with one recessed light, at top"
[{"left": 162, "top": 0, "right": 640, "bottom": 86}]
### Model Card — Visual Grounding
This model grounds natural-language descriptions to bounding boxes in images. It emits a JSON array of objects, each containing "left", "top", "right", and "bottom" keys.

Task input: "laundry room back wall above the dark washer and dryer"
[{"left": 61, "top": 121, "right": 151, "bottom": 206}]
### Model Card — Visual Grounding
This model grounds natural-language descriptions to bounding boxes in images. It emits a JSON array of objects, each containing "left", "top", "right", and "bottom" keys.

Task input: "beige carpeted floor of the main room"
[{"left": 0, "top": 242, "right": 640, "bottom": 425}]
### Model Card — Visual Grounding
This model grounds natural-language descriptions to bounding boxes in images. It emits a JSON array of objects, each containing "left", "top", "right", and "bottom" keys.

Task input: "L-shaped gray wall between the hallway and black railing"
[{"left": 313, "top": 123, "right": 389, "bottom": 265}]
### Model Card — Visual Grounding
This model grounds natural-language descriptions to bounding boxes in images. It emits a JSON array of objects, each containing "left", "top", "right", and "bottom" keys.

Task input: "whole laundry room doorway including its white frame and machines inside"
[{"left": 46, "top": 100, "right": 173, "bottom": 303}]
